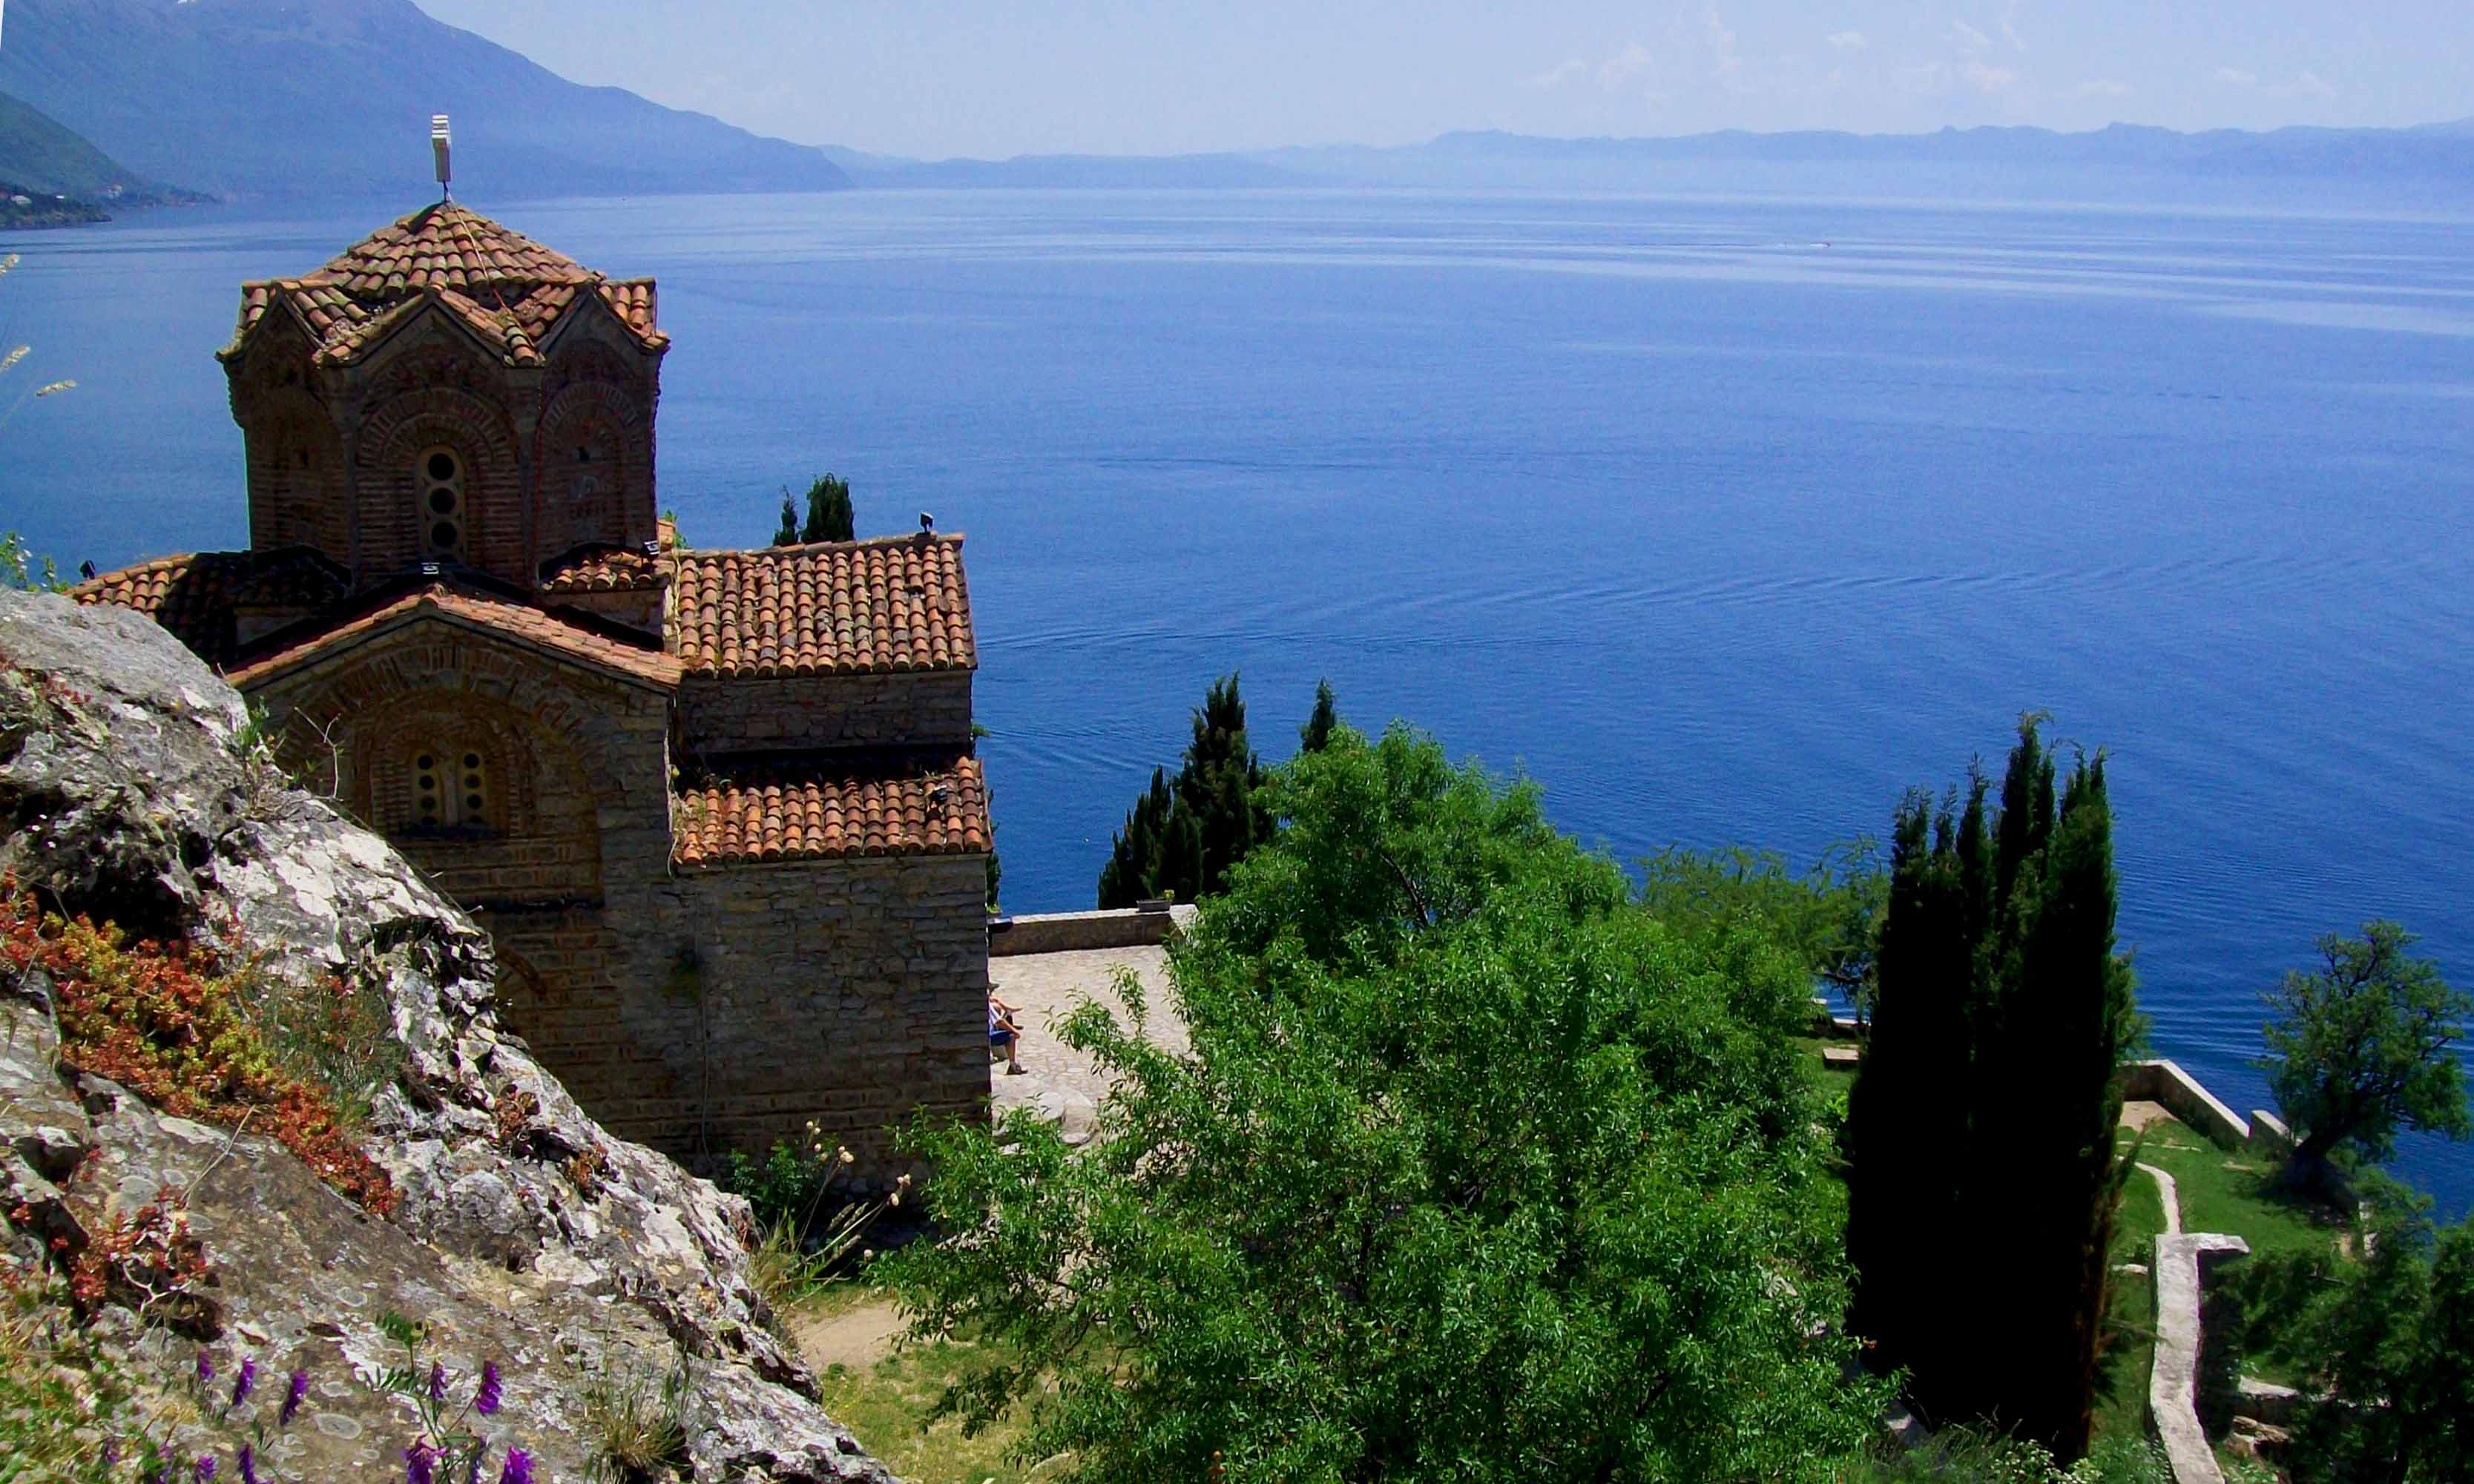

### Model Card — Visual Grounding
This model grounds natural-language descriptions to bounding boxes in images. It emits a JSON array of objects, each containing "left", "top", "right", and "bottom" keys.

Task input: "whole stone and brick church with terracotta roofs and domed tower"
[{"left": 74, "top": 202, "right": 990, "bottom": 1173}]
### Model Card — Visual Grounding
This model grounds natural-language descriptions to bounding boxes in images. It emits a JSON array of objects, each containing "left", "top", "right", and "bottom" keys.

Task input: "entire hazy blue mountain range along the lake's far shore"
[{"left": 0, "top": 0, "right": 2474, "bottom": 210}]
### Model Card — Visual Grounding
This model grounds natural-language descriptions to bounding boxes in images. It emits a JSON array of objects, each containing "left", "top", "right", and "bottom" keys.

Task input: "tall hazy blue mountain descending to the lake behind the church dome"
[{"left": 0, "top": 0, "right": 849, "bottom": 198}]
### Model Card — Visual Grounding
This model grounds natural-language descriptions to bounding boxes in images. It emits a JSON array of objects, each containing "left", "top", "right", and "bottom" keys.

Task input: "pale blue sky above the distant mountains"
[{"left": 418, "top": 0, "right": 2474, "bottom": 156}]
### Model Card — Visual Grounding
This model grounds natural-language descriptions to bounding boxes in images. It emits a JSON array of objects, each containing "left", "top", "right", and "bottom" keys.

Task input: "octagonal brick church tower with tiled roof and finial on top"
[{"left": 217, "top": 116, "right": 671, "bottom": 610}]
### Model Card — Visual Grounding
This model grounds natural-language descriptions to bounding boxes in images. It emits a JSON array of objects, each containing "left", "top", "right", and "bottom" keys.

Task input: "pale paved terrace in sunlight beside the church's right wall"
[{"left": 987, "top": 947, "right": 1185, "bottom": 1143}]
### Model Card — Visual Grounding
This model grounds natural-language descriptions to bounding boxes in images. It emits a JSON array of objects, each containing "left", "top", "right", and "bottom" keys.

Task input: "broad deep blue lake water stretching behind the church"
[{"left": 0, "top": 191, "right": 2474, "bottom": 1212}]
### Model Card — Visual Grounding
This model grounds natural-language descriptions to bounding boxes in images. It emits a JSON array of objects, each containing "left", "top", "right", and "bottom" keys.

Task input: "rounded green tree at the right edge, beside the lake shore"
[{"left": 2259, "top": 923, "right": 2474, "bottom": 1180}]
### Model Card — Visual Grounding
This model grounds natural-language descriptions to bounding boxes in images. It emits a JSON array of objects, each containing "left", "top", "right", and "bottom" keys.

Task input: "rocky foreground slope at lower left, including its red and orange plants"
[{"left": 0, "top": 589, "right": 891, "bottom": 1484}]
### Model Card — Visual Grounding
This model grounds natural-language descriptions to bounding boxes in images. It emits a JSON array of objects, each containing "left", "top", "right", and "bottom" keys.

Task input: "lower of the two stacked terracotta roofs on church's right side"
[{"left": 671, "top": 754, "right": 992, "bottom": 865}]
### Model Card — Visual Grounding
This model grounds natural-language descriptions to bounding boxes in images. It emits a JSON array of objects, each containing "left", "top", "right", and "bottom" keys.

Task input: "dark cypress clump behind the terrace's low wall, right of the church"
[{"left": 1099, "top": 675, "right": 1271, "bottom": 908}]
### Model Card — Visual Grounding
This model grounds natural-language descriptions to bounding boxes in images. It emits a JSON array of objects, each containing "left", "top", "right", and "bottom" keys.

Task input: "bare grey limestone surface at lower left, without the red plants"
[{"left": 0, "top": 591, "right": 888, "bottom": 1482}]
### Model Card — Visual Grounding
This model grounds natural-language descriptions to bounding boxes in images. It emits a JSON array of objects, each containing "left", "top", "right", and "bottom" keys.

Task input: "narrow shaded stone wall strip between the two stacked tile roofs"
[{"left": 678, "top": 670, "right": 970, "bottom": 757}]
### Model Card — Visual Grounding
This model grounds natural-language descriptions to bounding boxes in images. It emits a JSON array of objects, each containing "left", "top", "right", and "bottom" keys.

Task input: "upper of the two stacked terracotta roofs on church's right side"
[{"left": 671, "top": 534, "right": 980, "bottom": 675}]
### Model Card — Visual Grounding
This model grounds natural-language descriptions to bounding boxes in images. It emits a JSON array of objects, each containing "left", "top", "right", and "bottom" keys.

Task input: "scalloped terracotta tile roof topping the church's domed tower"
[{"left": 223, "top": 200, "right": 668, "bottom": 366}]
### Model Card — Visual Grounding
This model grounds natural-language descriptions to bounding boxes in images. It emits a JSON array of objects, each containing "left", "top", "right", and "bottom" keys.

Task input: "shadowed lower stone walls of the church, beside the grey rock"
[{"left": 255, "top": 623, "right": 990, "bottom": 1182}]
